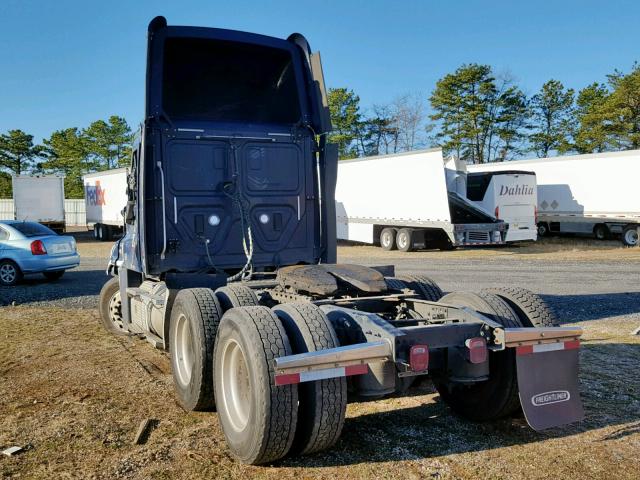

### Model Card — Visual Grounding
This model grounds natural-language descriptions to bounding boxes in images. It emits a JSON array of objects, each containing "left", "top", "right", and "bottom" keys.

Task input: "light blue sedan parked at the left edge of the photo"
[{"left": 0, "top": 220, "right": 80, "bottom": 285}]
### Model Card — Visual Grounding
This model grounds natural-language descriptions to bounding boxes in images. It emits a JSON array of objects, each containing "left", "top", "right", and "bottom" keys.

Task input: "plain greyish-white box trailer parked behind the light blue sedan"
[{"left": 12, "top": 175, "right": 65, "bottom": 233}]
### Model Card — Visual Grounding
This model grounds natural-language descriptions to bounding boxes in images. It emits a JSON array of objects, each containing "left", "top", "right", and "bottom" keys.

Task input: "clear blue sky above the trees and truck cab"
[{"left": 0, "top": 0, "right": 640, "bottom": 141}]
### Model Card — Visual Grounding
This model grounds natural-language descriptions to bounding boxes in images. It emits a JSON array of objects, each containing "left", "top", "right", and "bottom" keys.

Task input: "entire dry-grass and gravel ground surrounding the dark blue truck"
[{"left": 0, "top": 237, "right": 640, "bottom": 480}]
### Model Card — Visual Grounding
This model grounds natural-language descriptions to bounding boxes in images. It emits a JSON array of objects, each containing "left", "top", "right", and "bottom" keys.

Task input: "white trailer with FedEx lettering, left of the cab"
[{"left": 82, "top": 168, "right": 127, "bottom": 241}]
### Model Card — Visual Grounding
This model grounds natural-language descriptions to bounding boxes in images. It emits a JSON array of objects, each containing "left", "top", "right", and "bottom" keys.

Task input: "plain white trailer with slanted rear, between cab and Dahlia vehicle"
[{"left": 335, "top": 148, "right": 508, "bottom": 251}]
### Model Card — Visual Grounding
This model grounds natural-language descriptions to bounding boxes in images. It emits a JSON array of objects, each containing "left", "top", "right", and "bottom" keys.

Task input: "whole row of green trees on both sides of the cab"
[{"left": 0, "top": 63, "right": 640, "bottom": 198}]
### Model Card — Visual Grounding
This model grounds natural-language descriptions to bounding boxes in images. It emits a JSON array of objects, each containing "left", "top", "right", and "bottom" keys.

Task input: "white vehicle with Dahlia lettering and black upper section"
[{"left": 467, "top": 170, "right": 538, "bottom": 242}]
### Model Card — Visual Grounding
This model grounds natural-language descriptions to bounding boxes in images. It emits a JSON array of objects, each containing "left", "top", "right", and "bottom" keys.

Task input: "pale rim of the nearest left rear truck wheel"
[{"left": 221, "top": 339, "right": 251, "bottom": 432}]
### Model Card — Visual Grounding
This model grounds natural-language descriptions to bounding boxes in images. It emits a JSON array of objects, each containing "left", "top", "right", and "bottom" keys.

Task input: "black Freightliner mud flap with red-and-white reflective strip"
[{"left": 516, "top": 340, "right": 584, "bottom": 430}]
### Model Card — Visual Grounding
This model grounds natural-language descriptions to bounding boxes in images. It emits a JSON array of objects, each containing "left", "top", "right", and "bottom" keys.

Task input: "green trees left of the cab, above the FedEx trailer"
[{"left": 0, "top": 115, "right": 133, "bottom": 198}]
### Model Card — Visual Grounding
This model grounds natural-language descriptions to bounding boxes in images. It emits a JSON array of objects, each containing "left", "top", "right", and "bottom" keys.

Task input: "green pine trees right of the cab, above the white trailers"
[{"left": 328, "top": 63, "right": 640, "bottom": 163}]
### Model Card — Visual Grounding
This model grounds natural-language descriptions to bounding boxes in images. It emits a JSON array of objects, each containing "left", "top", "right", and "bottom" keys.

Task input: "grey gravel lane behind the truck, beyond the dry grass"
[{"left": 0, "top": 233, "right": 640, "bottom": 330}]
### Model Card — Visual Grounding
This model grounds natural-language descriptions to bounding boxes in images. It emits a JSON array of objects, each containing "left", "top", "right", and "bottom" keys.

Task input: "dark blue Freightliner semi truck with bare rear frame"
[{"left": 99, "top": 17, "right": 583, "bottom": 464}]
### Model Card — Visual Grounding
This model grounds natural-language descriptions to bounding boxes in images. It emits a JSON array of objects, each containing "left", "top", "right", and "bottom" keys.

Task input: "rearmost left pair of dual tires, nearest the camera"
[{"left": 214, "top": 303, "right": 347, "bottom": 465}]
